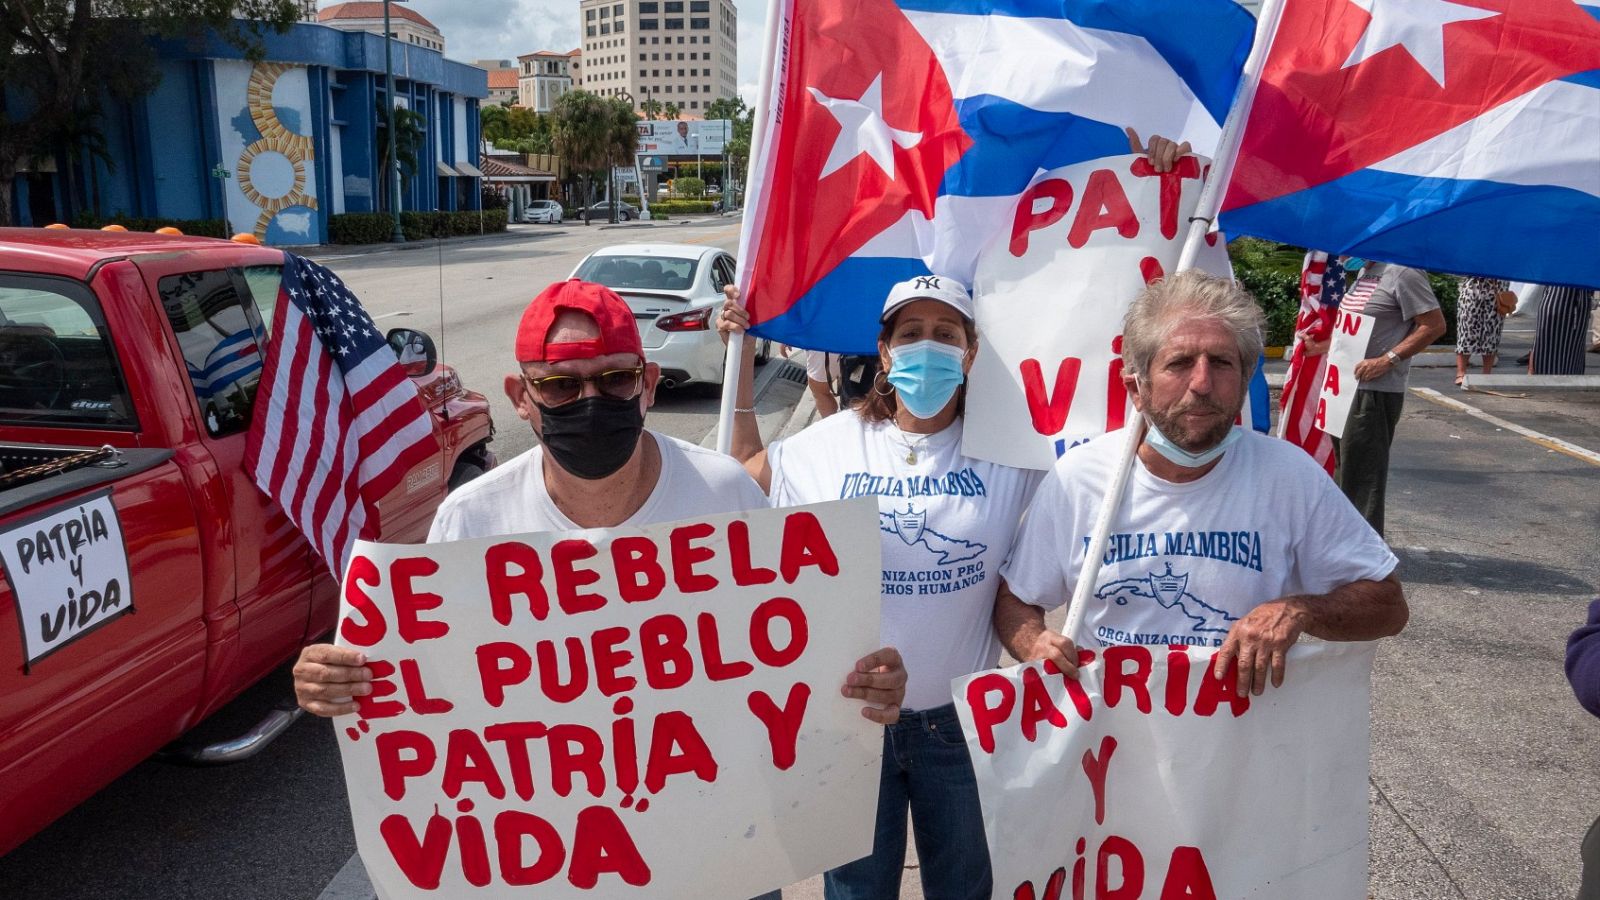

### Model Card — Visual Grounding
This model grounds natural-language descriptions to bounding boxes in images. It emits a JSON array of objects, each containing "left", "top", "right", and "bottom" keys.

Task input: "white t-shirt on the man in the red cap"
[{"left": 427, "top": 431, "right": 766, "bottom": 543}]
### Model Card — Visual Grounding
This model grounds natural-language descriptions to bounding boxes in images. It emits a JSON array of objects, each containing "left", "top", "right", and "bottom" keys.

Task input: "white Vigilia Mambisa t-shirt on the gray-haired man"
[{"left": 1000, "top": 431, "right": 1398, "bottom": 647}]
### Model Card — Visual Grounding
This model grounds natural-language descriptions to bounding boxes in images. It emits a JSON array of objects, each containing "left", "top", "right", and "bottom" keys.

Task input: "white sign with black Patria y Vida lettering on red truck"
[{"left": 0, "top": 488, "right": 133, "bottom": 665}]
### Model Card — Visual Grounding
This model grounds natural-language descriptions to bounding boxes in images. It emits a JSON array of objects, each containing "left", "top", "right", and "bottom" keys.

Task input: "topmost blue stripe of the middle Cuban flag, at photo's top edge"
[{"left": 896, "top": 0, "right": 1256, "bottom": 120}]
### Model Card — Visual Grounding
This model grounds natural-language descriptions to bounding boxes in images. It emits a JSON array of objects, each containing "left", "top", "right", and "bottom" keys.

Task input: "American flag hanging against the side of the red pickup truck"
[{"left": 245, "top": 253, "right": 438, "bottom": 578}]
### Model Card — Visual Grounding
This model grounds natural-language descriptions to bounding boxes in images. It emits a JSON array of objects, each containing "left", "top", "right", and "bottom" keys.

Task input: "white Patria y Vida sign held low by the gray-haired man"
[{"left": 952, "top": 642, "right": 1376, "bottom": 900}]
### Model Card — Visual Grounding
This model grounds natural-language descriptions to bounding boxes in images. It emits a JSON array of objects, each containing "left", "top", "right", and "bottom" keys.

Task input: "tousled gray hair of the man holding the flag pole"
[{"left": 1122, "top": 269, "right": 1266, "bottom": 383}]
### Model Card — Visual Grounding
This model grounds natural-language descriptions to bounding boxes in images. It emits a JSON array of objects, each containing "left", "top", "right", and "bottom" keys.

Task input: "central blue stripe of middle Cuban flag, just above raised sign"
[{"left": 939, "top": 96, "right": 1128, "bottom": 197}]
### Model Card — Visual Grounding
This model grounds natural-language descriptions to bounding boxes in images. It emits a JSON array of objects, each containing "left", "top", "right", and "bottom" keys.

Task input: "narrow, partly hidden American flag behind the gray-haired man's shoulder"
[{"left": 1278, "top": 250, "right": 1344, "bottom": 474}]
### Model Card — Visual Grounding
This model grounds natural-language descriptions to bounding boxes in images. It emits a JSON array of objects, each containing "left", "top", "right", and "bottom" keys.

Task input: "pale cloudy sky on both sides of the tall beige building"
[{"left": 400, "top": 0, "right": 766, "bottom": 102}]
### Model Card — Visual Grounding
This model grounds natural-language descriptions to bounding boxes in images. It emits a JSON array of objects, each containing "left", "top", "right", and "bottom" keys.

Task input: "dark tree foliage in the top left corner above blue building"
[{"left": 0, "top": 0, "right": 301, "bottom": 224}]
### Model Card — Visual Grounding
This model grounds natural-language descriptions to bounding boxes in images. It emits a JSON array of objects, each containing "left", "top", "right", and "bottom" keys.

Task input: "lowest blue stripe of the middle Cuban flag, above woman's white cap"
[{"left": 750, "top": 256, "right": 930, "bottom": 354}]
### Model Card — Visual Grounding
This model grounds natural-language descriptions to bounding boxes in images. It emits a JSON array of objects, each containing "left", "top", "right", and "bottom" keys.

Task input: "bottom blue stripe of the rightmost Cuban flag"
[{"left": 1221, "top": 170, "right": 1600, "bottom": 287}]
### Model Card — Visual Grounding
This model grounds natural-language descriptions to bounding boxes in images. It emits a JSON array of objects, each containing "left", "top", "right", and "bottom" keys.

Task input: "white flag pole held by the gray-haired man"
[{"left": 1061, "top": 0, "right": 1283, "bottom": 647}]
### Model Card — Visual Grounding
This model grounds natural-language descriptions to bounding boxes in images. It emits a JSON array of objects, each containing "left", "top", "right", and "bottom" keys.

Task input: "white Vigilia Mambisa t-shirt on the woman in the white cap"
[{"left": 766, "top": 412, "right": 1043, "bottom": 709}]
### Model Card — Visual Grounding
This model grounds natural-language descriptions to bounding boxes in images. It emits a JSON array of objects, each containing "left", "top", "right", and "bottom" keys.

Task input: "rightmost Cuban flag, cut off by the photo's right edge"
[{"left": 1221, "top": 0, "right": 1600, "bottom": 287}]
